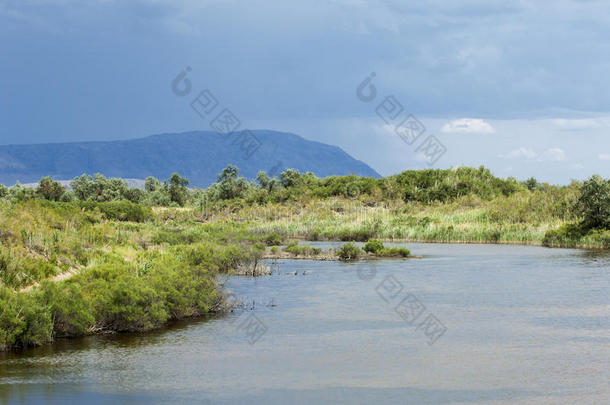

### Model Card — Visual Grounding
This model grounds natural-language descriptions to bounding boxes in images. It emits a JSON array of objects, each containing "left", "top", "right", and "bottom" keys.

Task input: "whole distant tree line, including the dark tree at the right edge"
[{"left": 0, "top": 165, "right": 610, "bottom": 229}]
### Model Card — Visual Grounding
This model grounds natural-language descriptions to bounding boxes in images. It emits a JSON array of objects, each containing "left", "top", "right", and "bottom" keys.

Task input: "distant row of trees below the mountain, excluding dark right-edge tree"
[{"left": 0, "top": 165, "right": 552, "bottom": 208}]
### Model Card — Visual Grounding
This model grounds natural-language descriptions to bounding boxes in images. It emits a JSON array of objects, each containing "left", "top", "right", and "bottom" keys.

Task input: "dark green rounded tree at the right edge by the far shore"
[{"left": 577, "top": 175, "right": 610, "bottom": 229}]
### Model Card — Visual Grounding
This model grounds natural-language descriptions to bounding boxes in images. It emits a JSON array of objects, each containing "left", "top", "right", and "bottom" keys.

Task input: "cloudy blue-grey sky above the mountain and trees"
[{"left": 0, "top": 0, "right": 610, "bottom": 184}]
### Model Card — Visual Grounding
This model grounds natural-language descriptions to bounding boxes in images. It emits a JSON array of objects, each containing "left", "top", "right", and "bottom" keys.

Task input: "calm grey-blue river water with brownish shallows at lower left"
[{"left": 0, "top": 243, "right": 610, "bottom": 404}]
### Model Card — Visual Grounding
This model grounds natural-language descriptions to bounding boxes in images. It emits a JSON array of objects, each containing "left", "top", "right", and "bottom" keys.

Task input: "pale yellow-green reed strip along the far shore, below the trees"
[{"left": 196, "top": 192, "right": 572, "bottom": 245}]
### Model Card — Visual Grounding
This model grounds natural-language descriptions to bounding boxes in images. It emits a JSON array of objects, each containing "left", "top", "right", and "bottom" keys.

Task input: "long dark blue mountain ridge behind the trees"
[{"left": 0, "top": 130, "right": 379, "bottom": 187}]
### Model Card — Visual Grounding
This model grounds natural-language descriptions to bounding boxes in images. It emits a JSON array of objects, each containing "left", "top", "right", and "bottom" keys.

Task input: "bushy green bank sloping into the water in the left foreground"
[{"left": 0, "top": 201, "right": 264, "bottom": 350}]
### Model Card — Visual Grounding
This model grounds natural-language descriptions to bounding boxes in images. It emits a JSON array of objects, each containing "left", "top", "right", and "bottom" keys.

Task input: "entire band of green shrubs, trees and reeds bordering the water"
[{"left": 0, "top": 166, "right": 610, "bottom": 350}]
